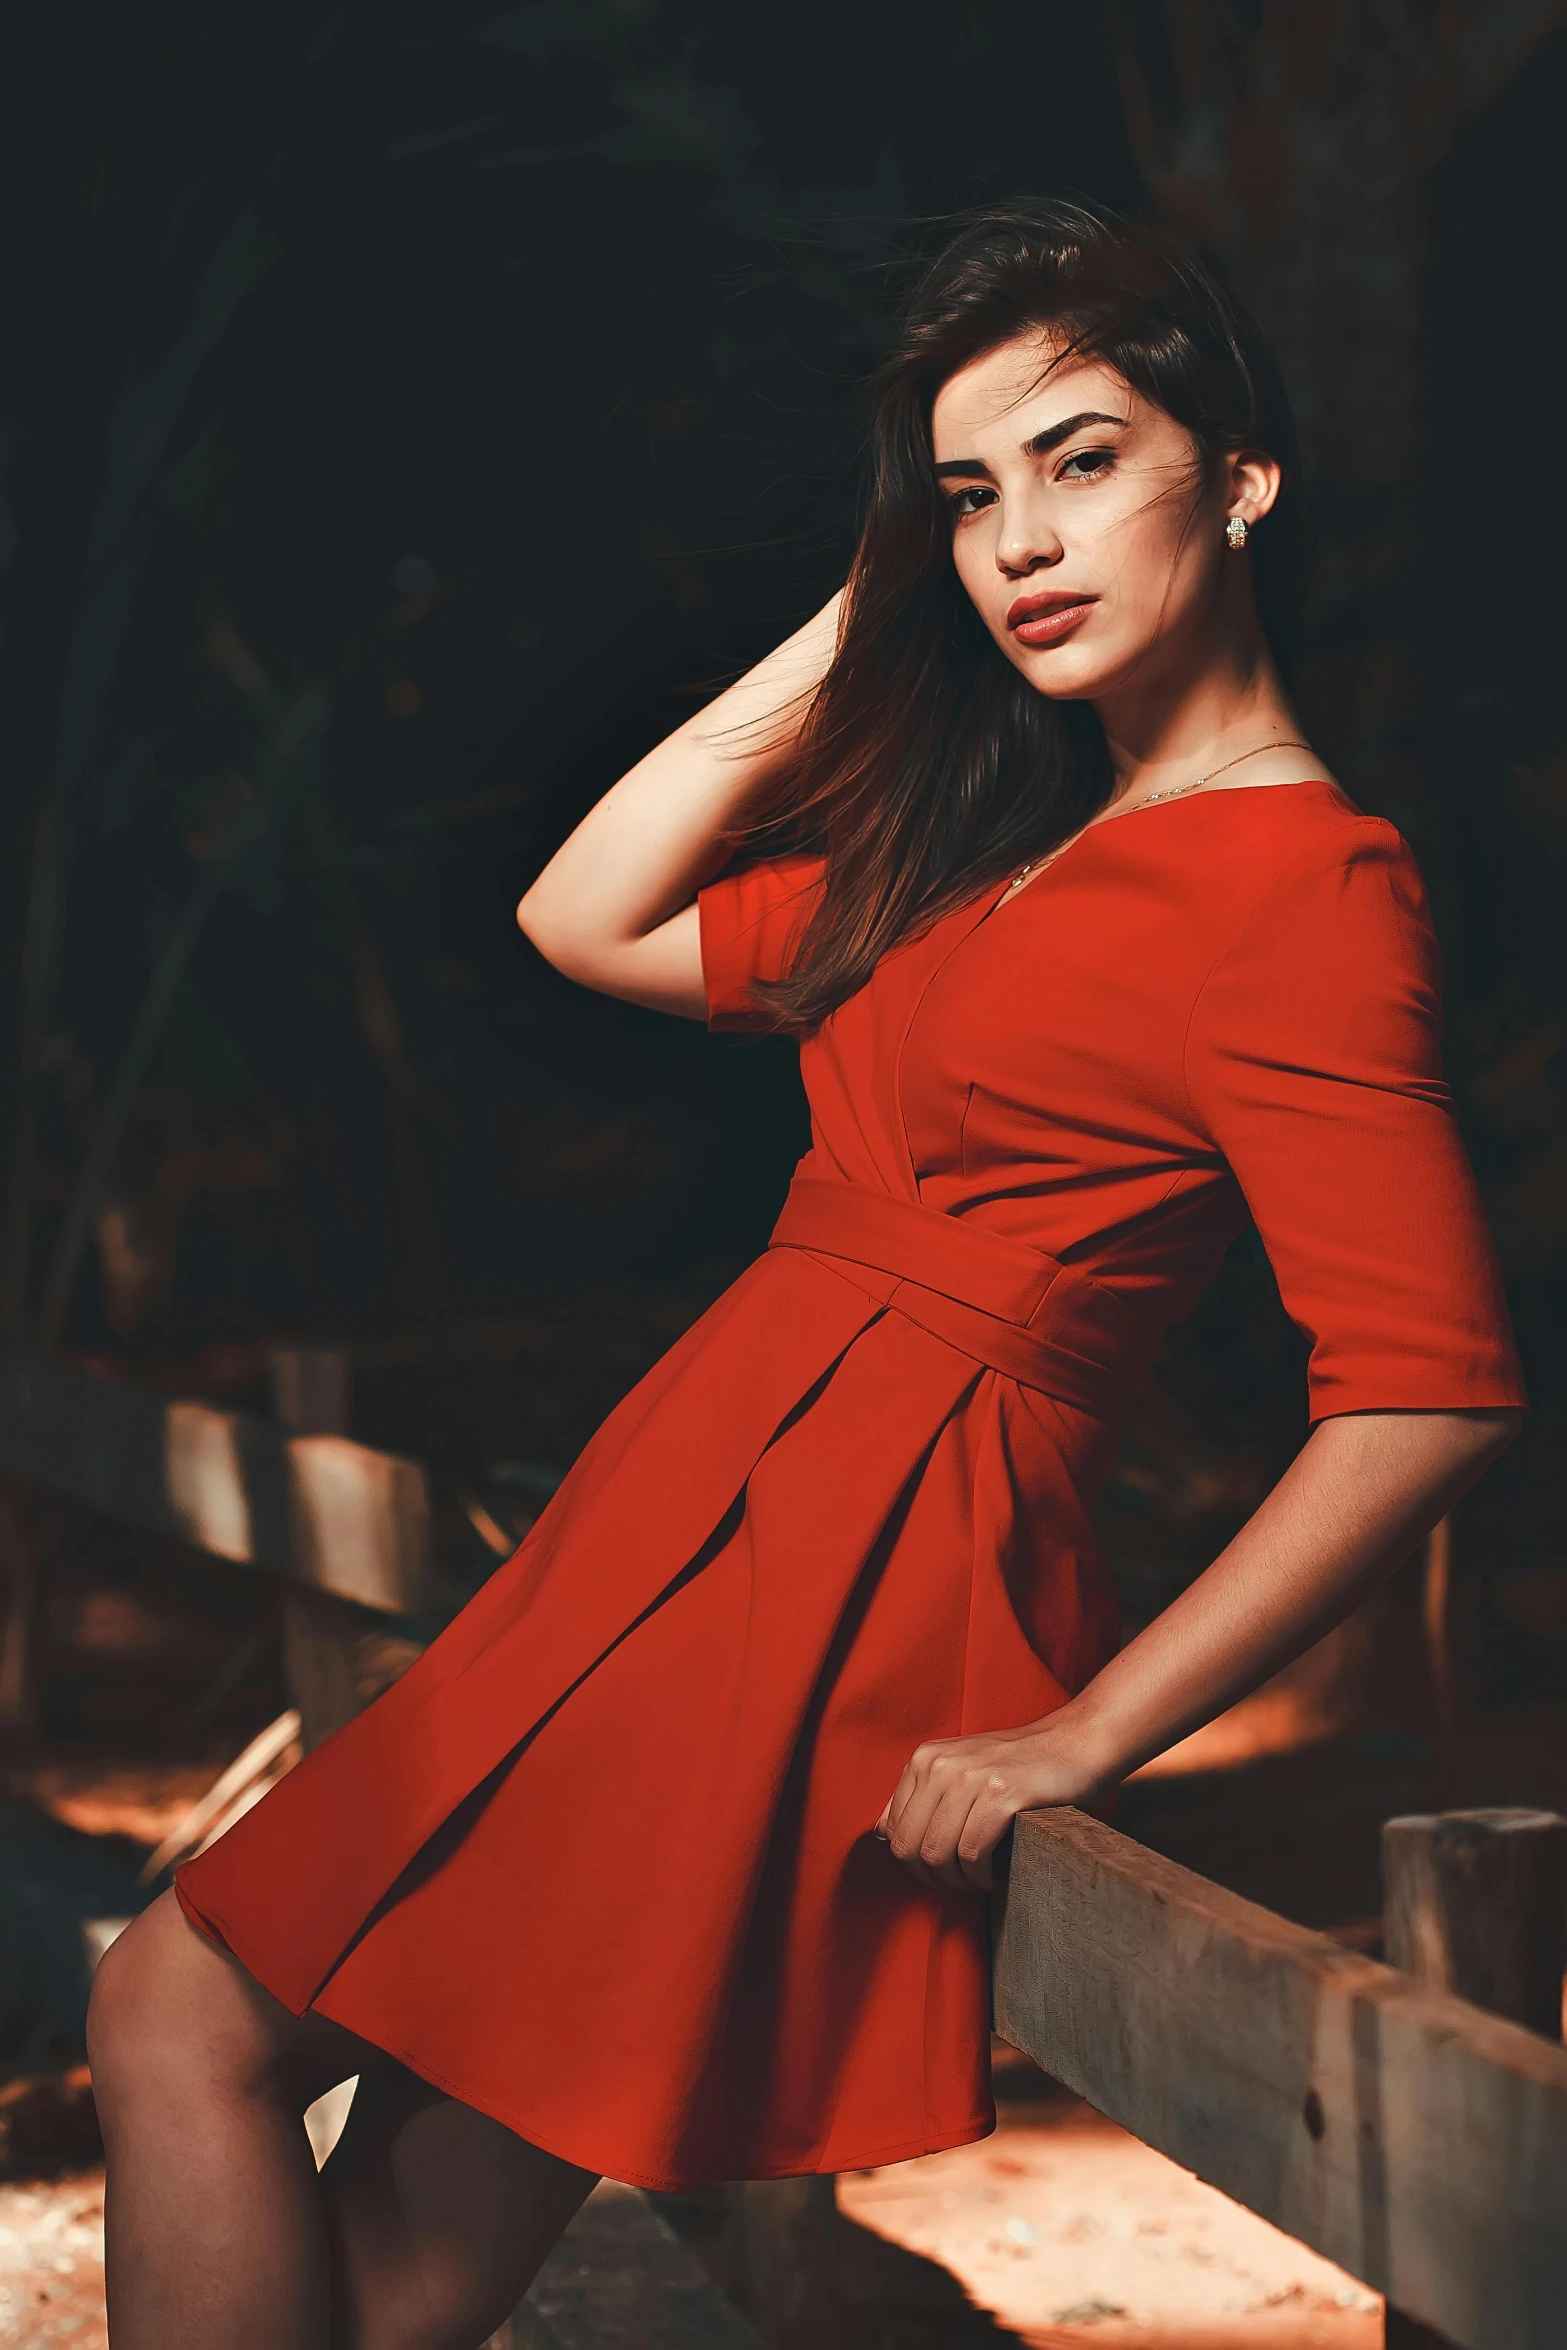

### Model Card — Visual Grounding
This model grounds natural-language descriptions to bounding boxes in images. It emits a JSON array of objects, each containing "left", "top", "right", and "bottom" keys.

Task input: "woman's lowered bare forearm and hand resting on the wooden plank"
[{"left": 876, "top": 1410, "right": 1522, "bottom": 1887}]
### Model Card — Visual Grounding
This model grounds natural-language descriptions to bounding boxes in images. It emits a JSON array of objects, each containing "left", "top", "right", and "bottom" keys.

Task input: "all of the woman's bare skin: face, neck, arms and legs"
[{"left": 89, "top": 338, "right": 1518, "bottom": 2350}]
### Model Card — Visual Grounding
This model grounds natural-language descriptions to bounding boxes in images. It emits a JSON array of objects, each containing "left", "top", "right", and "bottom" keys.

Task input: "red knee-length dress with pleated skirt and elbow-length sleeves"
[{"left": 179, "top": 783, "right": 1522, "bottom": 2188}]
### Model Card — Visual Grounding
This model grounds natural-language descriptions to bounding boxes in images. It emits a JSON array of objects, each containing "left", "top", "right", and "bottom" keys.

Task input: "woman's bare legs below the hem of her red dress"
[{"left": 89, "top": 1894, "right": 592, "bottom": 2350}]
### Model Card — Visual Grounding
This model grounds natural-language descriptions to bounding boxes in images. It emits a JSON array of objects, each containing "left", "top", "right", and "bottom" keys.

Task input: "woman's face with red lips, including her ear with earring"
[{"left": 930, "top": 334, "right": 1278, "bottom": 700}]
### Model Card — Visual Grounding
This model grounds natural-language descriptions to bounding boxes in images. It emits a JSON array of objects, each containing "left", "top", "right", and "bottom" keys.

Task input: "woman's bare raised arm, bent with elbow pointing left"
[{"left": 517, "top": 597, "right": 841, "bottom": 1020}]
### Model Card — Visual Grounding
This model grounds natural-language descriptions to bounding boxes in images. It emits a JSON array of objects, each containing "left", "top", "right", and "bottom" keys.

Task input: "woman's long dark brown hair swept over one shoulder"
[{"left": 742, "top": 202, "right": 1309, "bottom": 1032}]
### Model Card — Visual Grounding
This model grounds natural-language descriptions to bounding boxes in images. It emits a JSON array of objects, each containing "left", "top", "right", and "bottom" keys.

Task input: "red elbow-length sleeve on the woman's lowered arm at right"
[{"left": 1186, "top": 818, "right": 1525, "bottom": 1419}]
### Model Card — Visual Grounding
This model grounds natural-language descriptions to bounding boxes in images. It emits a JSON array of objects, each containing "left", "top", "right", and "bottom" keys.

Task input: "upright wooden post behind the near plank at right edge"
[{"left": 1381, "top": 1810, "right": 1567, "bottom": 2350}]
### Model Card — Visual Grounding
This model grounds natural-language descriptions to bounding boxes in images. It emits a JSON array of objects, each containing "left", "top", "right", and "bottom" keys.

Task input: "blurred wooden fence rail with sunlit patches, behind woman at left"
[{"left": 0, "top": 1354, "right": 430, "bottom": 1612}]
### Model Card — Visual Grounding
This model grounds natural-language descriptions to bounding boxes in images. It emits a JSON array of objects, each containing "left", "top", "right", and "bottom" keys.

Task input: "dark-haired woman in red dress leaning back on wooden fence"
[{"left": 92, "top": 207, "right": 1522, "bottom": 2350}]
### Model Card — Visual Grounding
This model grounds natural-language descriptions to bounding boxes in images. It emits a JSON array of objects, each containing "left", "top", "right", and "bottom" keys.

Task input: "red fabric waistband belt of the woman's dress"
[{"left": 768, "top": 1175, "right": 1161, "bottom": 1419}]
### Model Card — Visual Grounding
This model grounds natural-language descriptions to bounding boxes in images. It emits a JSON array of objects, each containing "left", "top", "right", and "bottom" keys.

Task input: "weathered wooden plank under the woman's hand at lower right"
[{"left": 996, "top": 1810, "right": 1567, "bottom": 2350}]
